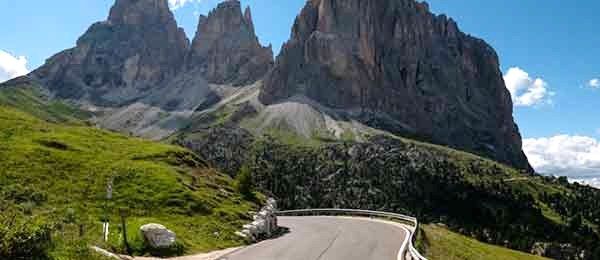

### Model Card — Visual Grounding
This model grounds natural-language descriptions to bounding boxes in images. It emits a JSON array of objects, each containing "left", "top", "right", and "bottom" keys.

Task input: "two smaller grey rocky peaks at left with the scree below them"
[{"left": 18, "top": 0, "right": 273, "bottom": 139}]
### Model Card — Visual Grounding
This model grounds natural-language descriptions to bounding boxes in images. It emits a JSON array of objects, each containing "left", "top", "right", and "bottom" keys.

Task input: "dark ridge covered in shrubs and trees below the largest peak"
[{"left": 175, "top": 112, "right": 600, "bottom": 259}]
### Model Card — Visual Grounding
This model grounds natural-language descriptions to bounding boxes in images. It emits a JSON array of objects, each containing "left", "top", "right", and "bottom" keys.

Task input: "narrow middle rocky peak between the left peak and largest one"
[{"left": 186, "top": 0, "right": 273, "bottom": 85}]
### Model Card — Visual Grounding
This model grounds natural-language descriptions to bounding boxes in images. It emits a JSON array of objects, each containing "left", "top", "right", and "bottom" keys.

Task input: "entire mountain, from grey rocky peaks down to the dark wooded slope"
[{"left": 0, "top": 0, "right": 600, "bottom": 259}]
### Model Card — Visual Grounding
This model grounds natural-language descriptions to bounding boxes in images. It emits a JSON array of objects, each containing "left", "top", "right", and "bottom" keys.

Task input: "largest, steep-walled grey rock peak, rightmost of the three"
[{"left": 260, "top": 0, "right": 531, "bottom": 171}]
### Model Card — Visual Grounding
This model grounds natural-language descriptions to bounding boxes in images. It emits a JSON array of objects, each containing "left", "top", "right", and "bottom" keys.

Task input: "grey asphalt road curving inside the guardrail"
[{"left": 221, "top": 217, "right": 408, "bottom": 260}]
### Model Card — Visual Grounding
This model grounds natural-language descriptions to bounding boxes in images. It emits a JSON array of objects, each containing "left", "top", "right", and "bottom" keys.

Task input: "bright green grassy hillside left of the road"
[{"left": 0, "top": 106, "right": 256, "bottom": 259}]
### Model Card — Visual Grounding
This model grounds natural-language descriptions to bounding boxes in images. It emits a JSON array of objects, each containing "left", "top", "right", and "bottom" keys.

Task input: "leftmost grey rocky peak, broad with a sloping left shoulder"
[{"left": 32, "top": 0, "right": 189, "bottom": 106}]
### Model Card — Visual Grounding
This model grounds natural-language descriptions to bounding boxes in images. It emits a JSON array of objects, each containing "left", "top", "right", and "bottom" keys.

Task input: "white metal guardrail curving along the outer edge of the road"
[{"left": 275, "top": 209, "right": 427, "bottom": 260}]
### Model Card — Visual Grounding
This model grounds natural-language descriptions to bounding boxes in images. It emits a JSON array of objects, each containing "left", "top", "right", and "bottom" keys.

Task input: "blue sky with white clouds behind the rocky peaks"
[{"left": 0, "top": 0, "right": 600, "bottom": 183}]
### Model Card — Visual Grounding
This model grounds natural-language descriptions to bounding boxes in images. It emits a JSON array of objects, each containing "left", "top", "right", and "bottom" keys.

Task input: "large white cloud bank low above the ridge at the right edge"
[{"left": 523, "top": 135, "right": 600, "bottom": 187}]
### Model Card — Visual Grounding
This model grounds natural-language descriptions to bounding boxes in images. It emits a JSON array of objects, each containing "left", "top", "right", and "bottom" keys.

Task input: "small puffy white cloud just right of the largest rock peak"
[{"left": 504, "top": 67, "right": 554, "bottom": 106}]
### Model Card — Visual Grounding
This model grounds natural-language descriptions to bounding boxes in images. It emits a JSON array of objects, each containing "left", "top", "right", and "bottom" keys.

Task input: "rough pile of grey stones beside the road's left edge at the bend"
[{"left": 237, "top": 199, "right": 279, "bottom": 242}]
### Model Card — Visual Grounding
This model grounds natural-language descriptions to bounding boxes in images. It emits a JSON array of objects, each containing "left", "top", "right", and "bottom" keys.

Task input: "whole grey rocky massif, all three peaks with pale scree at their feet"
[{"left": 12, "top": 0, "right": 532, "bottom": 172}]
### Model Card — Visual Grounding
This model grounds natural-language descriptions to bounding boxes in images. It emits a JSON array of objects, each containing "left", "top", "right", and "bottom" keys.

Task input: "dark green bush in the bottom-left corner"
[{"left": 0, "top": 211, "right": 52, "bottom": 260}]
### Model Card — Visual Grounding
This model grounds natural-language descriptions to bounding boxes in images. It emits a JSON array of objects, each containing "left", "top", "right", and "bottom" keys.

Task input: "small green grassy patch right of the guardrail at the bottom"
[{"left": 419, "top": 224, "right": 547, "bottom": 260}]
